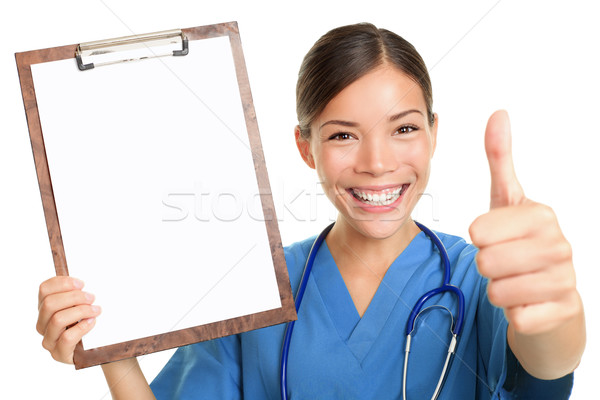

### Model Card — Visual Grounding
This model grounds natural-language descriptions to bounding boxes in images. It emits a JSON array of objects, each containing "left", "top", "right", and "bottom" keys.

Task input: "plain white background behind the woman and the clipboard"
[{"left": 0, "top": 0, "right": 600, "bottom": 400}]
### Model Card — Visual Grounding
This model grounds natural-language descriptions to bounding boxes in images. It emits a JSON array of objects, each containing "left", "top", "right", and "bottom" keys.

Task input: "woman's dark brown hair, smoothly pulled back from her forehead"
[{"left": 296, "top": 23, "right": 434, "bottom": 138}]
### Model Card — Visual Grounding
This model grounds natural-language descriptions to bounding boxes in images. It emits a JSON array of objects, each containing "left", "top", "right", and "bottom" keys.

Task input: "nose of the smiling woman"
[{"left": 356, "top": 132, "right": 398, "bottom": 176}]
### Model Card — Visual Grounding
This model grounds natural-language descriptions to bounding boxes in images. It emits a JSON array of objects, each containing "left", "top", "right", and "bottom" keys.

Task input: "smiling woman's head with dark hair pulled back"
[{"left": 296, "top": 23, "right": 437, "bottom": 248}]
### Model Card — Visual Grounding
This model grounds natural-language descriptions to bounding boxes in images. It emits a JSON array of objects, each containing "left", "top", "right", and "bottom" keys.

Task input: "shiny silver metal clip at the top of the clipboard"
[{"left": 75, "top": 29, "right": 189, "bottom": 71}]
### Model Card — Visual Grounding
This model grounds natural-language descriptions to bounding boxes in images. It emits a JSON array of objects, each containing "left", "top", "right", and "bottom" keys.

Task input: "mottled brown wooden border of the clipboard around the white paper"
[{"left": 15, "top": 22, "right": 296, "bottom": 369}]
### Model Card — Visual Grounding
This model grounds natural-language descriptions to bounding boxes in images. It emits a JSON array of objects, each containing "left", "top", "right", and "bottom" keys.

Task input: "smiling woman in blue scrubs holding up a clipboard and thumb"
[{"left": 38, "top": 24, "right": 585, "bottom": 399}]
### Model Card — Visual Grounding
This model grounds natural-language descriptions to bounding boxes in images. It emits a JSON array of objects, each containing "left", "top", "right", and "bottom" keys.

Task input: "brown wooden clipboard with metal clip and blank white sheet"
[{"left": 15, "top": 22, "right": 296, "bottom": 369}]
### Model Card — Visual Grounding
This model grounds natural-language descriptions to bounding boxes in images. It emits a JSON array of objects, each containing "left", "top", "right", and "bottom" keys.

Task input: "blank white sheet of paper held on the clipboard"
[{"left": 32, "top": 37, "right": 281, "bottom": 349}]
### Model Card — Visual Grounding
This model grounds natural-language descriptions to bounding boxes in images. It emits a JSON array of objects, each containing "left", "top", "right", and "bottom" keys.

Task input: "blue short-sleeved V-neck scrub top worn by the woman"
[{"left": 151, "top": 232, "right": 573, "bottom": 400}]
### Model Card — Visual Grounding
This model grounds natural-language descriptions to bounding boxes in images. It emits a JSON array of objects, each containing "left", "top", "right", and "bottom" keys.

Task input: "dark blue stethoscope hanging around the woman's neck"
[{"left": 279, "top": 221, "right": 465, "bottom": 400}]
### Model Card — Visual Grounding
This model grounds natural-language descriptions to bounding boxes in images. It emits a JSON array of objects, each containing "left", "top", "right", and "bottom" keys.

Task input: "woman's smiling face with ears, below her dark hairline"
[{"left": 296, "top": 66, "right": 437, "bottom": 239}]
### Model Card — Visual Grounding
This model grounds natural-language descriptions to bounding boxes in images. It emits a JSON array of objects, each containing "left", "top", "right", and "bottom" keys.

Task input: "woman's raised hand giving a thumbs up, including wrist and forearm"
[{"left": 469, "top": 111, "right": 585, "bottom": 379}]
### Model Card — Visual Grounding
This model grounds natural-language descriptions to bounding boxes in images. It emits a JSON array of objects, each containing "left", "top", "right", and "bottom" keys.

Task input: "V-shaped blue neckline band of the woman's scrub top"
[{"left": 311, "top": 232, "right": 432, "bottom": 363}]
